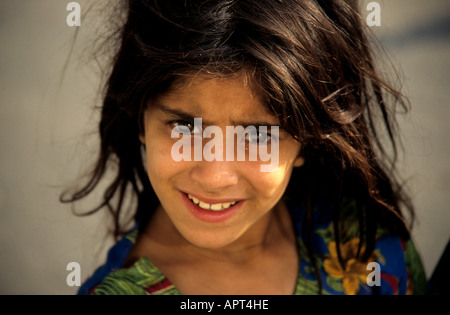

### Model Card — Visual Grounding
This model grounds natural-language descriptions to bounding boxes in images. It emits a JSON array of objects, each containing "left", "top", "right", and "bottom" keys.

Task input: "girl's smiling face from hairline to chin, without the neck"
[{"left": 141, "top": 76, "right": 303, "bottom": 249}]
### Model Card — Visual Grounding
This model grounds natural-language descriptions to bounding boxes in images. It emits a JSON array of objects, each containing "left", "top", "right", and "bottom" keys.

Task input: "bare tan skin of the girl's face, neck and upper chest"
[{"left": 132, "top": 75, "right": 304, "bottom": 294}]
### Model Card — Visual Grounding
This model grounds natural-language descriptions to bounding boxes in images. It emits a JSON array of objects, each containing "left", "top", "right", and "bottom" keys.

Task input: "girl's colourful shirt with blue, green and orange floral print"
[{"left": 78, "top": 201, "right": 428, "bottom": 295}]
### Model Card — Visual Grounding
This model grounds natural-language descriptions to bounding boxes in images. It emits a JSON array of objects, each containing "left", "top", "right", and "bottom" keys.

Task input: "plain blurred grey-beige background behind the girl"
[{"left": 0, "top": 0, "right": 450, "bottom": 294}]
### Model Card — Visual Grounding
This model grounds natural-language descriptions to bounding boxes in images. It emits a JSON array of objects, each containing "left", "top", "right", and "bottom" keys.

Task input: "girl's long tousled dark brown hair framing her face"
[{"left": 63, "top": 0, "right": 413, "bottom": 296}]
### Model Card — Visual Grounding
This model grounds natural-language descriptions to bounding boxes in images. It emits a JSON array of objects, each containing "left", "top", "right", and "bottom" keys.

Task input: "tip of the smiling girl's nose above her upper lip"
[{"left": 191, "top": 160, "right": 239, "bottom": 194}]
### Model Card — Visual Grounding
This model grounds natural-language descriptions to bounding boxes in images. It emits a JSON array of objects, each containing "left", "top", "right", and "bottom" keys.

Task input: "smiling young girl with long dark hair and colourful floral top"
[{"left": 66, "top": 0, "right": 426, "bottom": 295}]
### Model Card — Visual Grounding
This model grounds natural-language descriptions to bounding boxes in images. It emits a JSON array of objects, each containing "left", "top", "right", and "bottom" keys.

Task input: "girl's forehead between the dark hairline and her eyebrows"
[{"left": 158, "top": 74, "right": 278, "bottom": 125}]
